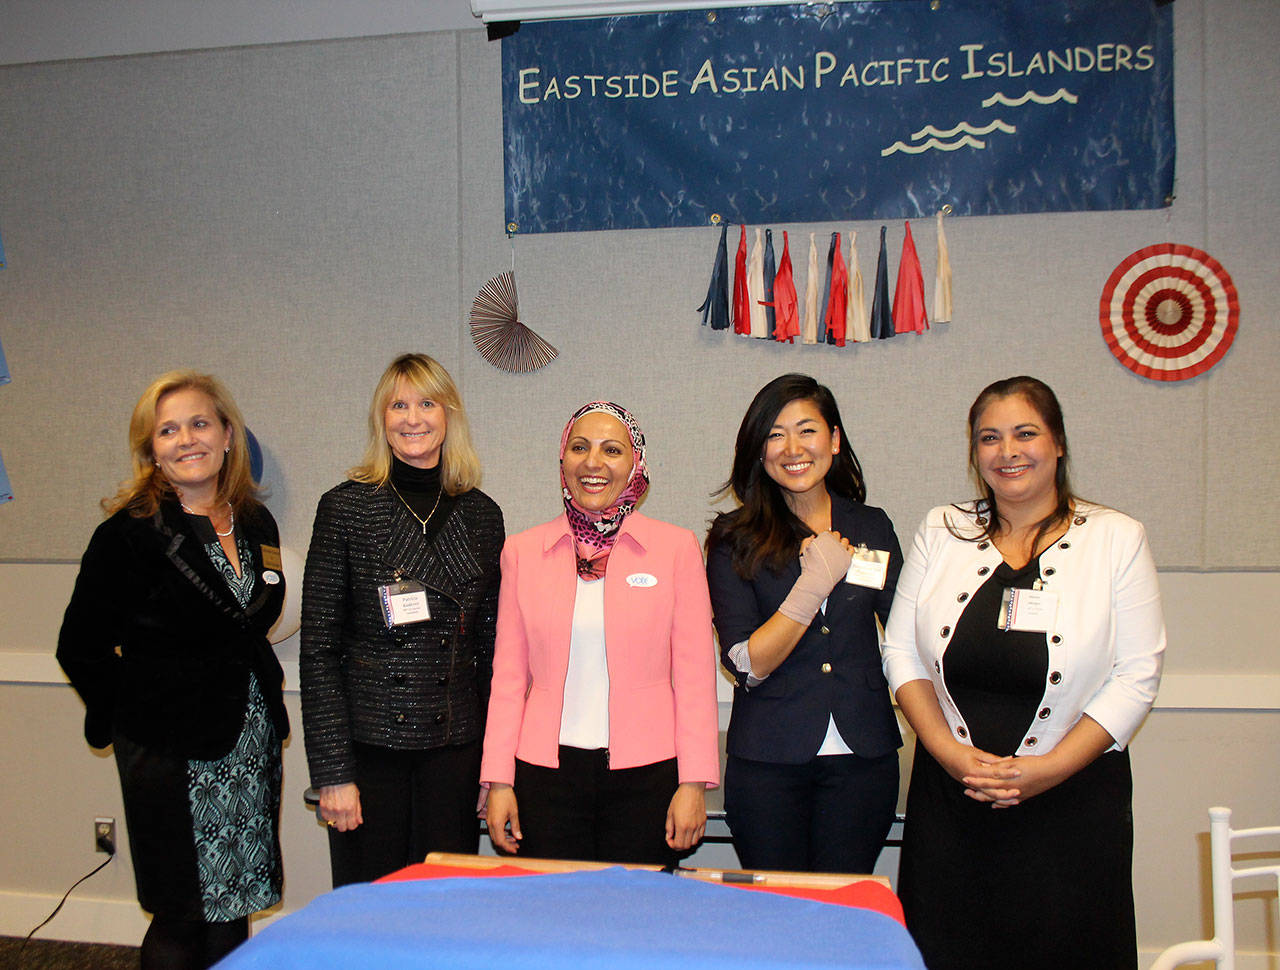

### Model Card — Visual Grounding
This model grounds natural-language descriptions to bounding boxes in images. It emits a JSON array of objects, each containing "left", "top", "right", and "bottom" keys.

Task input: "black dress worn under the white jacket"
[{"left": 899, "top": 559, "right": 1137, "bottom": 970}]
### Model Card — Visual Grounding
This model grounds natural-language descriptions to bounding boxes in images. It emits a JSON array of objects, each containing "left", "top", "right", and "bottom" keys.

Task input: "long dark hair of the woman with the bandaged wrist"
[{"left": 707, "top": 374, "right": 867, "bottom": 580}]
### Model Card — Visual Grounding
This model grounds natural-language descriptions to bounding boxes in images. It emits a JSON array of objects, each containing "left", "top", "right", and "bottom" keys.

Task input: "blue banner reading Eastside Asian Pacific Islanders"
[{"left": 502, "top": 0, "right": 1175, "bottom": 233}]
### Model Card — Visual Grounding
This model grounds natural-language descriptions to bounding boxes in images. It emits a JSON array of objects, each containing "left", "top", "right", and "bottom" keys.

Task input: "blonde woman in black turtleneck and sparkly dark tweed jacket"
[{"left": 301, "top": 353, "right": 504, "bottom": 887}]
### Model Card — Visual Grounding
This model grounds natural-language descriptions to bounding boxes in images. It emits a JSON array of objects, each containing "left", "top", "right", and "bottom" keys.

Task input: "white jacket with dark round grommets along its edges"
[{"left": 881, "top": 503, "right": 1165, "bottom": 755}]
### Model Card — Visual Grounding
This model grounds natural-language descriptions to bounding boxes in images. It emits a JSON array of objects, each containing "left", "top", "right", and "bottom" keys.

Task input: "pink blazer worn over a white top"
[{"left": 480, "top": 512, "right": 719, "bottom": 788}]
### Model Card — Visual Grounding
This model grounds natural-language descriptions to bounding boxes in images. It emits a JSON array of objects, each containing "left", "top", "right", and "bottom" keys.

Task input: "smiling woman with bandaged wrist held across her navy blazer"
[{"left": 707, "top": 374, "right": 902, "bottom": 873}]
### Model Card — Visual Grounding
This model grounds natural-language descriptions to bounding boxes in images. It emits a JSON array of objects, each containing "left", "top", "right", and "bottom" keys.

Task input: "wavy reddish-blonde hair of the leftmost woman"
[{"left": 102, "top": 370, "right": 257, "bottom": 518}]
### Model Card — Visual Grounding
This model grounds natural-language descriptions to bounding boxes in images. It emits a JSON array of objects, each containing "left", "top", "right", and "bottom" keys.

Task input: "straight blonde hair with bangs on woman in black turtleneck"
[{"left": 347, "top": 353, "right": 480, "bottom": 495}]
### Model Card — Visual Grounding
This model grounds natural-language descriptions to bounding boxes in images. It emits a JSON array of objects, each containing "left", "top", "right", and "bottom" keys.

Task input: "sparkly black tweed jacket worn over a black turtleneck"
[{"left": 300, "top": 481, "right": 504, "bottom": 787}]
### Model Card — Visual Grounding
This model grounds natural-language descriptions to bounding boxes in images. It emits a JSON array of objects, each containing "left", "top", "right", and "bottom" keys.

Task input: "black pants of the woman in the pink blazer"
[{"left": 515, "top": 745, "right": 680, "bottom": 865}]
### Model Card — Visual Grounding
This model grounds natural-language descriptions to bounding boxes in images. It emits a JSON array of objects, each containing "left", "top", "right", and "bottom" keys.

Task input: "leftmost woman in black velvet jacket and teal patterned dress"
[{"left": 58, "top": 371, "right": 289, "bottom": 970}]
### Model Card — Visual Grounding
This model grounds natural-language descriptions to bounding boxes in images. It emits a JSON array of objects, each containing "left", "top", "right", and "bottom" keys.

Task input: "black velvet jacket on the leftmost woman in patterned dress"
[{"left": 58, "top": 502, "right": 289, "bottom": 760}]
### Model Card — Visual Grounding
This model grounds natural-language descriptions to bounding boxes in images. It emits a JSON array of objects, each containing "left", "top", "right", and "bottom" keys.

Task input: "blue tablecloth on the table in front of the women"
[{"left": 218, "top": 869, "right": 924, "bottom": 970}]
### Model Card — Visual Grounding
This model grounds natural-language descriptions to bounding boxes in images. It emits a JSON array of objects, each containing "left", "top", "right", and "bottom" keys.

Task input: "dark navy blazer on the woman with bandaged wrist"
[{"left": 707, "top": 495, "right": 902, "bottom": 764}]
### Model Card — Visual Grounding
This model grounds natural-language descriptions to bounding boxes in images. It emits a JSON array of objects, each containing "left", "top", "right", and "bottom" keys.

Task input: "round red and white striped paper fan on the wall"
[{"left": 1098, "top": 243, "right": 1240, "bottom": 380}]
